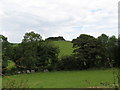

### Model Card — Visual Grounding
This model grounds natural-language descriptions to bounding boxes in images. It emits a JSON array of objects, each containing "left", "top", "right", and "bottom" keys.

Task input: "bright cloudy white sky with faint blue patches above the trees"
[{"left": 0, "top": 0, "right": 119, "bottom": 43}]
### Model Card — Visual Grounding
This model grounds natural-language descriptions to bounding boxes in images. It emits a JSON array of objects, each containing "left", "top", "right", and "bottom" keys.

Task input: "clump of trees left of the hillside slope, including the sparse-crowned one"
[{"left": 11, "top": 32, "right": 59, "bottom": 71}]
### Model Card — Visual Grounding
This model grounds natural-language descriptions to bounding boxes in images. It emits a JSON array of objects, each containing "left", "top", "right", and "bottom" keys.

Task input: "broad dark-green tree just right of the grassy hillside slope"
[{"left": 72, "top": 34, "right": 101, "bottom": 68}]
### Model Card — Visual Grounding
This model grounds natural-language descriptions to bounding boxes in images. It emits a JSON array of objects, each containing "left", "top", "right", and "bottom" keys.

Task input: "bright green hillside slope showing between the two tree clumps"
[{"left": 52, "top": 41, "right": 74, "bottom": 58}]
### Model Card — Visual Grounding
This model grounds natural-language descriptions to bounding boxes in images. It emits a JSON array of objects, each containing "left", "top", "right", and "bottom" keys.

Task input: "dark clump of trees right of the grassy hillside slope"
[{"left": 72, "top": 34, "right": 118, "bottom": 68}]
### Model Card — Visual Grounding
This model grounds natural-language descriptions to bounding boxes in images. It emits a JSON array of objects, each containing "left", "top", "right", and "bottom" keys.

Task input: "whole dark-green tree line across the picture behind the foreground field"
[{"left": 0, "top": 32, "right": 120, "bottom": 74}]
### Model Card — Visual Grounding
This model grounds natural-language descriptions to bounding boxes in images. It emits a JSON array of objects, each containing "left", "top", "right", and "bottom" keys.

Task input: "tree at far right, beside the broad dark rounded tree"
[{"left": 98, "top": 34, "right": 117, "bottom": 67}]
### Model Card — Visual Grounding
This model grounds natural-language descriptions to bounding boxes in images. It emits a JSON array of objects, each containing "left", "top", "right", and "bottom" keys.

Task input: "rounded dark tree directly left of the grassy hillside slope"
[{"left": 37, "top": 41, "right": 59, "bottom": 70}]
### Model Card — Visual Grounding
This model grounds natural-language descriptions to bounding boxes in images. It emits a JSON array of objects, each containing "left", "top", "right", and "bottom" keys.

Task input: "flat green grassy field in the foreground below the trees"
[{"left": 3, "top": 69, "right": 114, "bottom": 88}]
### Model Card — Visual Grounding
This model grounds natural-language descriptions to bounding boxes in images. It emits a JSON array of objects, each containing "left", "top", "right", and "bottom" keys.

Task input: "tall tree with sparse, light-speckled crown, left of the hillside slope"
[{"left": 16, "top": 32, "right": 42, "bottom": 70}]
